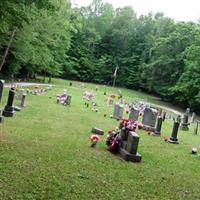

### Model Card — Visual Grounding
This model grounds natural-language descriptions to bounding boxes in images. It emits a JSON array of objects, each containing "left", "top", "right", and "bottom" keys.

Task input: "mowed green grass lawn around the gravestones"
[{"left": 0, "top": 79, "right": 200, "bottom": 200}]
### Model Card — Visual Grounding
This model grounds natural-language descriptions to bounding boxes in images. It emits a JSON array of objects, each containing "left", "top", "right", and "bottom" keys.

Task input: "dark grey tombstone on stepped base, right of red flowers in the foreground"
[{"left": 119, "top": 131, "right": 142, "bottom": 162}]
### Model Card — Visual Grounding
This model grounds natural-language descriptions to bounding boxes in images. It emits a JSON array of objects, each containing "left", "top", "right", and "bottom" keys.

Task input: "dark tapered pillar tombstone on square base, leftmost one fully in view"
[{"left": 3, "top": 88, "right": 15, "bottom": 117}]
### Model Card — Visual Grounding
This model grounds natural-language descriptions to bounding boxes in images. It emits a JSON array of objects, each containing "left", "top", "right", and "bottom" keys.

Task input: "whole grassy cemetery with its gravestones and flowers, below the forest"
[{"left": 0, "top": 79, "right": 200, "bottom": 199}]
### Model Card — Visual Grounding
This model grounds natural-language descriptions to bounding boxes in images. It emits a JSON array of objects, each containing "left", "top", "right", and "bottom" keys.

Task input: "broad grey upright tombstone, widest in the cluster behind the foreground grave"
[{"left": 142, "top": 108, "right": 157, "bottom": 131}]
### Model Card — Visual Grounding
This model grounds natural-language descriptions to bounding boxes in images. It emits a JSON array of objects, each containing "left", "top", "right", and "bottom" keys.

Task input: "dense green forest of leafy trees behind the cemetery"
[{"left": 0, "top": 0, "right": 200, "bottom": 112}]
